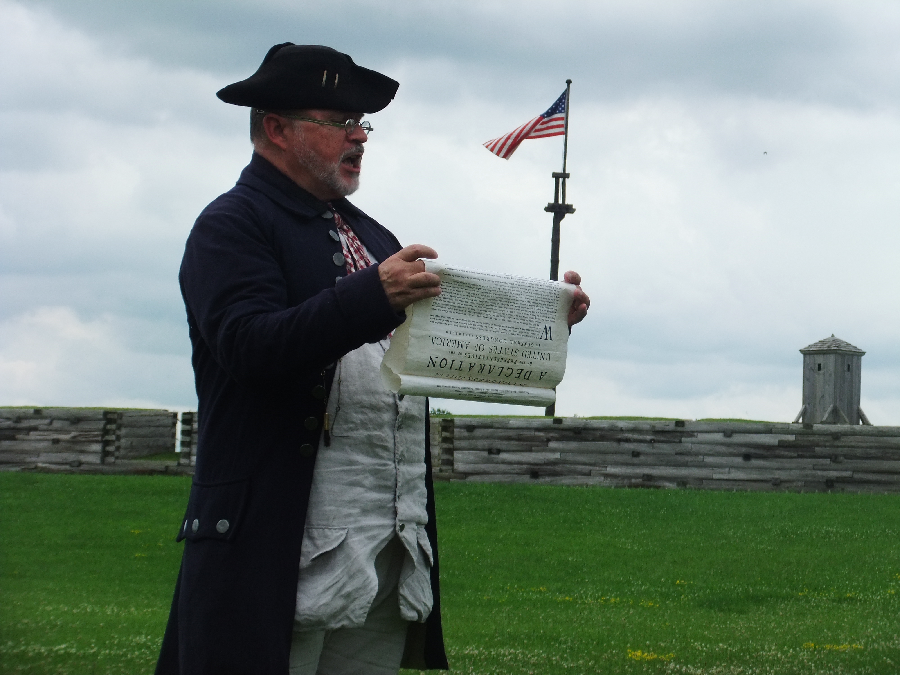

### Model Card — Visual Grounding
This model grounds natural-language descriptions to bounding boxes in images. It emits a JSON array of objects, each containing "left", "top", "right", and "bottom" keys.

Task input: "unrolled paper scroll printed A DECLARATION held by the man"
[{"left": 381, "top": 260, "right": 575, "bottom": 406}]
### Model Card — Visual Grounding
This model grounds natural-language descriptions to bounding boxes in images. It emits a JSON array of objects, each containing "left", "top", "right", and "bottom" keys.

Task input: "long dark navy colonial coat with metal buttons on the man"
[{"left": 156, "top": 155, "right": 447, "bottom": 675}]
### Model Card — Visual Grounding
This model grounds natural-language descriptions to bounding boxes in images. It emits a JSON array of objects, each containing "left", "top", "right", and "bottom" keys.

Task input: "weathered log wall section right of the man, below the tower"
[{"left": 436, "top": 417, "right": 900, "bottom": 492}]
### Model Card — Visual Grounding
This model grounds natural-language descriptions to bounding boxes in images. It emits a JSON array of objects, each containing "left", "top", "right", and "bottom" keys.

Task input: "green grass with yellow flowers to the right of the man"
[{"left": 439, "top": 485, "right": 900, "bottom": 674}]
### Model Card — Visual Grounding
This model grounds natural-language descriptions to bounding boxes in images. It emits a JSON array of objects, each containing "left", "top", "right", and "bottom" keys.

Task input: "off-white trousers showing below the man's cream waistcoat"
[{"left": 289, "top": 537, "right": 409, "bottom": 675}]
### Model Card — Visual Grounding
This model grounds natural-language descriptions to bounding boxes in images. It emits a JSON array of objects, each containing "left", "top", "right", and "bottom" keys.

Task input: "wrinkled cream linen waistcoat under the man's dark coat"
[{"left": 296, "top": 340, "right": 432, "bottom": 630}]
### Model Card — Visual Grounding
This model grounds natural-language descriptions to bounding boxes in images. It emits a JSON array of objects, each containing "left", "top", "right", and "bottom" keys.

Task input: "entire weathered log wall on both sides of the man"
[{"left": 7, "top": 408, "right": 900, "bottom": 492}]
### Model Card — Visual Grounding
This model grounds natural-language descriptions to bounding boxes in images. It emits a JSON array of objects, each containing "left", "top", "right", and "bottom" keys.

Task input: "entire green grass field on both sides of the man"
[{"left": 0, "top": 473, "right": 900, "bottom": 675}]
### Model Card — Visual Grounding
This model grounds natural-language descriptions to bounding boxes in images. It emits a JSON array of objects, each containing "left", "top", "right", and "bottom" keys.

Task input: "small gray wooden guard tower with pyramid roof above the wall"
[{"left": 794, "top": 335, "right": 870, "bottom": 424}]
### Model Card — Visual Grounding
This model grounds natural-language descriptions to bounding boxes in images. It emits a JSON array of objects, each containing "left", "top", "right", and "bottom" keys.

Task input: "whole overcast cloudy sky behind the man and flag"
[{"left": 0, "top": 0, "right": 900, "bottom": 425}]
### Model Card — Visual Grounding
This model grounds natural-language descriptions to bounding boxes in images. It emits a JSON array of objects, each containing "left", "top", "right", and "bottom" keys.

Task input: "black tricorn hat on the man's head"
[{"left": 216, "top": 42, "right": 400, "bottom": 113}]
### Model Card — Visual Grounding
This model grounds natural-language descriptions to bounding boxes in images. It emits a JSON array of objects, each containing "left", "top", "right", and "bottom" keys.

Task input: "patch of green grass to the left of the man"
[{"left": 0, "top": 473, "right": 190, "bottom": 675}]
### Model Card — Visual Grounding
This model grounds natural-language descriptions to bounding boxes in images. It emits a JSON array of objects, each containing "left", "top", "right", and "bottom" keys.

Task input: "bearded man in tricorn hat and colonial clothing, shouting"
[{"left": 156, "top": 43, "right": 589, "bottom": 675}]
